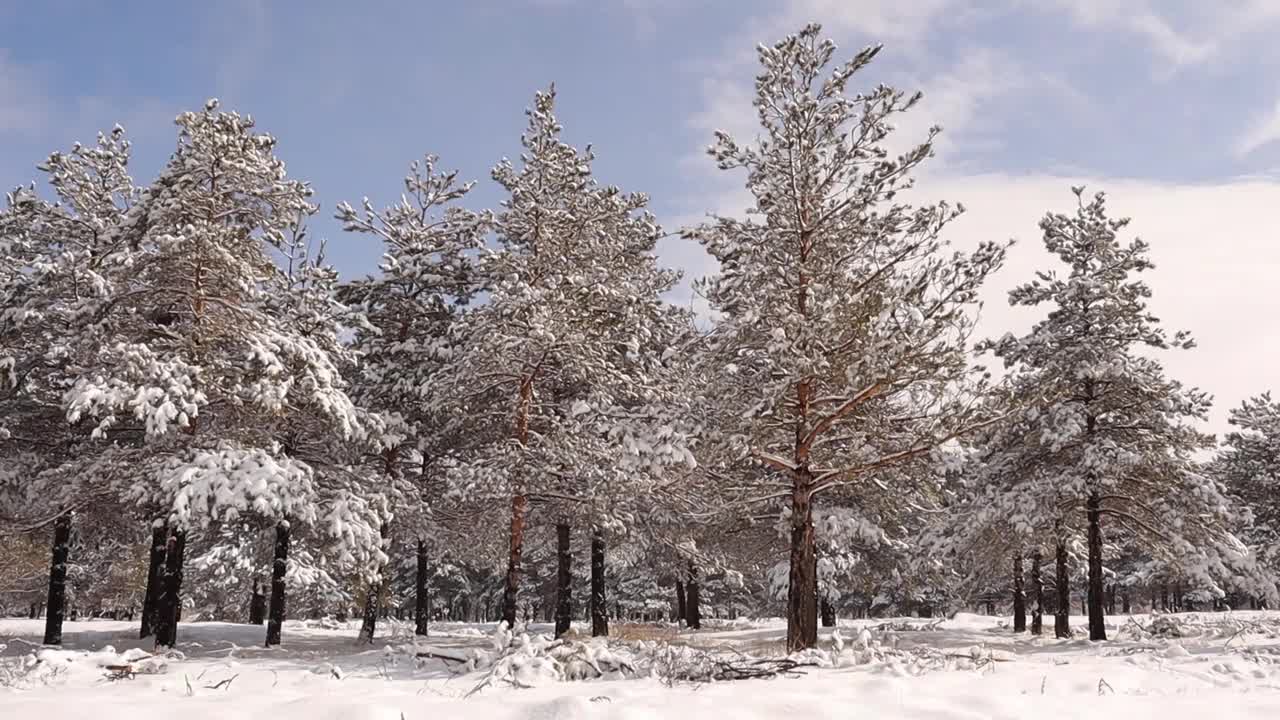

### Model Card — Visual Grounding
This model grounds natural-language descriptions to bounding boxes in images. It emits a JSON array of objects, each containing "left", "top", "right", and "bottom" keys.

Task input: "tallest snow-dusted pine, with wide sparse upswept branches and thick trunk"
[{"left": 690, "top": 24, "right": 1005, "bottom": 650}]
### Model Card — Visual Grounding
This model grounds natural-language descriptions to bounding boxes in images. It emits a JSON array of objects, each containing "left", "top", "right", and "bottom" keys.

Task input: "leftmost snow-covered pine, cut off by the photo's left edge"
[{"left": 0, "top": 126, "right": 137, "bottom": 644}]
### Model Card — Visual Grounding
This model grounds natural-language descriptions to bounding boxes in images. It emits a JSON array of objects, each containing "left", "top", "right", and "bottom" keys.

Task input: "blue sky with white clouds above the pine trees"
[{"left": 0, "top": 0, "right": 1280, "bottom": 429}]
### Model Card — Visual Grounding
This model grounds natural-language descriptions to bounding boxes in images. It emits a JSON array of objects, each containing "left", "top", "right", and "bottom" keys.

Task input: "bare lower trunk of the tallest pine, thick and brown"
[{"left": 787, "top": 468, "right": 818, "bottom": 652}]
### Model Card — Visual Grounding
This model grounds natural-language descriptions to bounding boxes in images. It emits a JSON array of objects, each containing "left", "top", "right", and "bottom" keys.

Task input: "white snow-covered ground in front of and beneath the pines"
[{"left": 0, "top": 612, "right": 1280, "bottom": 720}]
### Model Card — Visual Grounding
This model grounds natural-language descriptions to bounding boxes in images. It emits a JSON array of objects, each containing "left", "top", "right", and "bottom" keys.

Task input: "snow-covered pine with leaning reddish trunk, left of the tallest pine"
[{"left": 431, "top": 88, "right": 690, "bottom": 624}]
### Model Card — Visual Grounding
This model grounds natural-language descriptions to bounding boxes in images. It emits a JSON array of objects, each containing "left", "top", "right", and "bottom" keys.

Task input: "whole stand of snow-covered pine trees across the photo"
[{"left": 0, "top": 24, "right": 1280, "bottom": 666}]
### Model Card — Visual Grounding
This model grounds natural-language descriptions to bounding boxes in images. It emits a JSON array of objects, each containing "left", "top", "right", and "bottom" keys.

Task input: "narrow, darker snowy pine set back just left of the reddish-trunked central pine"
[{"left": 337, "top": 155, "right": 484, "bottom": 639}]
